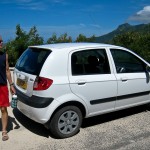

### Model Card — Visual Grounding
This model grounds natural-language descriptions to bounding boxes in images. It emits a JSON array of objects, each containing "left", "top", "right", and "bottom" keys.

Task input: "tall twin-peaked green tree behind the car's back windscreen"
[{"left": 6, "top": 24, "right": 43, "bottom": 66}]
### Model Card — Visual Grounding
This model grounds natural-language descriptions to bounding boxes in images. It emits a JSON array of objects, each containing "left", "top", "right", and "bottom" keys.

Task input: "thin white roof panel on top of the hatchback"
[{"left": 29, "top": 43, "right": 122, "bottom": 51}]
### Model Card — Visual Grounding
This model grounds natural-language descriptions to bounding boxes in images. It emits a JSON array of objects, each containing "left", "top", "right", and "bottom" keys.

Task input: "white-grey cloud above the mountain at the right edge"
[{"left": 128, "top": 6, "right": 150, "bottom": 23}]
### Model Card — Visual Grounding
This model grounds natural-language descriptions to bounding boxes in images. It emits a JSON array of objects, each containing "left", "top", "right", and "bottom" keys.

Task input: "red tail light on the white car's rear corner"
[{"left": 33, "top": 77, "right": 53, "bottom": 91}]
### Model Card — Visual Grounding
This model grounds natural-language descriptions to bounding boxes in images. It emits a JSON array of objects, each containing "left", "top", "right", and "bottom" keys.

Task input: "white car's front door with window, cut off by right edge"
[{"left": 110, "top": 49, "right": 150, "bottom": 108}]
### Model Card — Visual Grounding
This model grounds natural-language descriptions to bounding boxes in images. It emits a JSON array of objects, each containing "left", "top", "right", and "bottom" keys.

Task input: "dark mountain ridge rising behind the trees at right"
[{"left": 95, "top": 23, "right": 150, "bottom": 43}]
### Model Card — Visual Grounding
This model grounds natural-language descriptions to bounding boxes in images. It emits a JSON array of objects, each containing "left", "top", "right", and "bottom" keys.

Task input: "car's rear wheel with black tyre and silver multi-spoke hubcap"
[{"left": 49, "top": 106, "right": 82, "bottom": 139}]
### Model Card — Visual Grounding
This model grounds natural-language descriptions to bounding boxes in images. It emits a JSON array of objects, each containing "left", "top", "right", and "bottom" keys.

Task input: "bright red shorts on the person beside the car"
[{"left": 0, "top": 85, "right": 10, "bottom": 107}]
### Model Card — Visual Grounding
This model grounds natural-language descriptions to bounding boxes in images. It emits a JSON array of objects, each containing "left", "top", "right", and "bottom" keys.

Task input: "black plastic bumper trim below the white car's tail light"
[{"left": 16, "top": 89, "right": 54, "bottom": 108}]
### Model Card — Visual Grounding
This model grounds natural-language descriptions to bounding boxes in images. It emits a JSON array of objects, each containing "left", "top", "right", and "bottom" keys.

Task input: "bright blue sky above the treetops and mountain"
[{"left": 0, "top": 0, "right": 150, "bottom": 42}]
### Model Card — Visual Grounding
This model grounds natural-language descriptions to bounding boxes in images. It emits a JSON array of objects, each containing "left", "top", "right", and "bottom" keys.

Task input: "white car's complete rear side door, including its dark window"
[{"left": 69, "top": 49, "right": 117, "bottom": 116}]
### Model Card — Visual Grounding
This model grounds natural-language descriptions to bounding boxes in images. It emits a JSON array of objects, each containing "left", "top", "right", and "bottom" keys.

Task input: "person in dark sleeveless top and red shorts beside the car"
[{"left": 0, "top": 36, "right": 16, "bottom": 141}]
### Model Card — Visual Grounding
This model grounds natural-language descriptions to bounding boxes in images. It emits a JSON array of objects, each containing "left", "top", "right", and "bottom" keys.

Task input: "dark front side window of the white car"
[{"left": 110, "top": 49, "right": 145, "bottom": 73}]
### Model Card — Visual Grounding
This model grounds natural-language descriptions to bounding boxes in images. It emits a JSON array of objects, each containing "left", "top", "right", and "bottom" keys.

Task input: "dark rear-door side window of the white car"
[{"left": 71, "top": 49, "right": 110, "bottom": 75}]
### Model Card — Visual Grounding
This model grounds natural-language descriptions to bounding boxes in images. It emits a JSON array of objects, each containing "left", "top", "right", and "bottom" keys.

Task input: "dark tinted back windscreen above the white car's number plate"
[{"left": 15, "top": 48, "right": 51, "bottom": 75}]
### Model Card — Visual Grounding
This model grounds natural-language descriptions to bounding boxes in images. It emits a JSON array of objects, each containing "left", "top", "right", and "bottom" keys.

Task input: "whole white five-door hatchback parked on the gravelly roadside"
[{"left": 14, "top": 43, "right": 150, "bottom": 138}]
